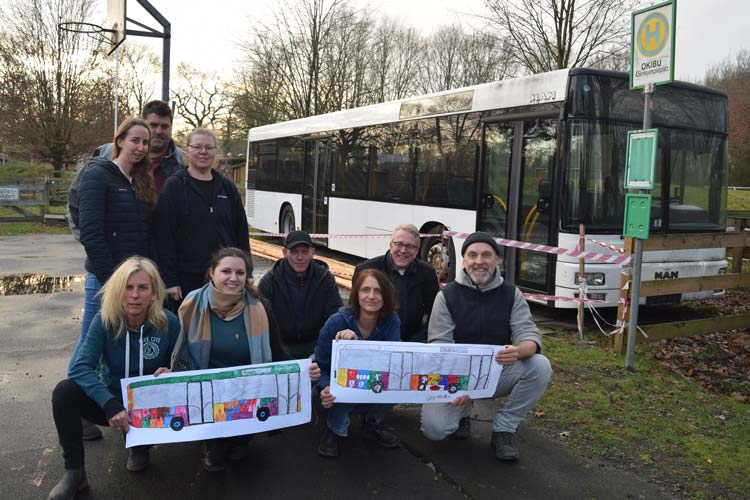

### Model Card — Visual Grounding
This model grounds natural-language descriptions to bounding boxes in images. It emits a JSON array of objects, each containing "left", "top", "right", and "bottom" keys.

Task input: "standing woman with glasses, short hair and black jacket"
[{"left": 154, "top": 128, "right": 252, "bottom": 311}]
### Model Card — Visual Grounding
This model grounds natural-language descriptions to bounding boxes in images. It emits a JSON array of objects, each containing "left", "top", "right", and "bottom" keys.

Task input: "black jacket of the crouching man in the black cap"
[{"left": 258, "top": 259, "right": 343, "bottom": 344}]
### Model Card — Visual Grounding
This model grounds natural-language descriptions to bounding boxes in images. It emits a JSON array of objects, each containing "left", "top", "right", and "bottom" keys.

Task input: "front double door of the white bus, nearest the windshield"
[{"left": 477, "top": 119, "right": 557, "bottom": 293}]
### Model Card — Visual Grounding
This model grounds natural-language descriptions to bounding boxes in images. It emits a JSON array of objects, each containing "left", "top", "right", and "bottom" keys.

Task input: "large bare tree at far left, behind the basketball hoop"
[{"left": 0, "top": 0, "right": 112, "bottom": 171}]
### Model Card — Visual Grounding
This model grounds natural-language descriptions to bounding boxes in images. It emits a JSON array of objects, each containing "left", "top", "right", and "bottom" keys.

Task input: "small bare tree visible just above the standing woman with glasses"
[{"left": 172, "top": 62, "right": 228, "bottom": 128}]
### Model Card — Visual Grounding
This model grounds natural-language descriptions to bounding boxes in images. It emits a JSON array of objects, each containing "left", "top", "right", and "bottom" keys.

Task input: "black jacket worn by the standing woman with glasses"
[{"left": 154, "top": 169, "right": 252, "bottom": 293}]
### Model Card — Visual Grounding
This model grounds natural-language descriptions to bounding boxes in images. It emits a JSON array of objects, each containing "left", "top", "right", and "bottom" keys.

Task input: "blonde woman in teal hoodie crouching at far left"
[{"left": 49, "top": 257, "right": 180, "bottom": 500}]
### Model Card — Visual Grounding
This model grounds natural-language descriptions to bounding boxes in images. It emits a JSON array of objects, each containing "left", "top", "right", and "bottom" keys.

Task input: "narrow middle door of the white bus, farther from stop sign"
[{"left": 302, "top": 139, "right": 335, "bottom": 246}]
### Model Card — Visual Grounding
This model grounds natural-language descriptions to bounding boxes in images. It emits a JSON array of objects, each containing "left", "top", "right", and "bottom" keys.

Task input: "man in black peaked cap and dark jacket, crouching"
[{"left": 258, "top": 231, "right": 343, "bottom": 359}]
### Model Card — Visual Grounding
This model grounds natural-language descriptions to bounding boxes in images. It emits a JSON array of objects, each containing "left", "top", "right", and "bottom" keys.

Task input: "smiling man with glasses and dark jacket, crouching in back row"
[{"left": 352, "top": 224, "right": 439, "bottom": 342}]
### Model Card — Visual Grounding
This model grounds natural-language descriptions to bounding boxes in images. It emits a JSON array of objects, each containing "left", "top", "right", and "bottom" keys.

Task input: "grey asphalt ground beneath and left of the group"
[{"left": 0, "top": 235, "right": 671, "bottom": 500}]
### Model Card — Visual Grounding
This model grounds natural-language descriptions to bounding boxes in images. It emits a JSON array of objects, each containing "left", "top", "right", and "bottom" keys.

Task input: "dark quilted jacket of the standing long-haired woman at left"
[{"left": 78, "top": 158, "right": 151, "bottom": 285}]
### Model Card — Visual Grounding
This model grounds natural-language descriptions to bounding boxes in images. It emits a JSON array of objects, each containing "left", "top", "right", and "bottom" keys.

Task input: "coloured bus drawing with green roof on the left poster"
[{"left": 127, "top": 363, "right": 302, "bottom": 431}]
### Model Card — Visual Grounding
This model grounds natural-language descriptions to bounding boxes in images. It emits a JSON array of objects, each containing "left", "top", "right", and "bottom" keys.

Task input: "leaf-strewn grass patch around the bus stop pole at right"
[{"left": 531, "top": 332, "right": 750, "bottom": 499}]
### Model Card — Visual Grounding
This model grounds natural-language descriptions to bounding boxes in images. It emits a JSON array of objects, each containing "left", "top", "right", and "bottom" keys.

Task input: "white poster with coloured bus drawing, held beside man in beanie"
[{"left": 331, "top": 340, "right": 503, "bottom": 403}]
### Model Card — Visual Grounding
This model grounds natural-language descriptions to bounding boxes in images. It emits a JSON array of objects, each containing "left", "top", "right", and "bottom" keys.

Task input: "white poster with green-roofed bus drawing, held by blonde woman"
[{"left": 122, "top": 359, "right": 311, "bottom": 448}]
